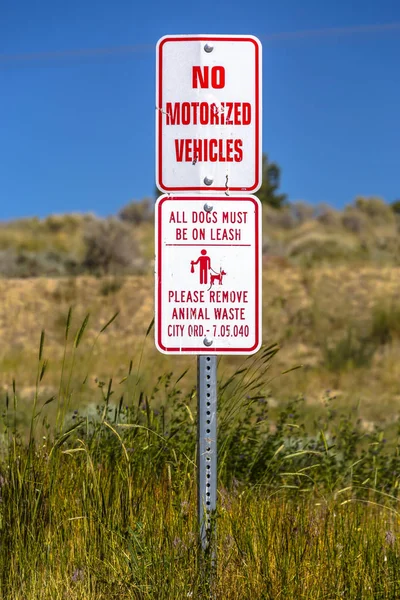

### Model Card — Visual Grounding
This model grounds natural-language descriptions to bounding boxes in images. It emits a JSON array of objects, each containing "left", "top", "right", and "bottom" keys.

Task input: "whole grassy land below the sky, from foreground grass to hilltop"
[{"left": 0, "top": 201, "right": 400, "bottom": 599}]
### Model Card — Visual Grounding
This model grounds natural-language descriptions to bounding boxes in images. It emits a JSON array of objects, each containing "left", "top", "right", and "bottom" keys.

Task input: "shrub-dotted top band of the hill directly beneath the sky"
[{"left": 0, "top": 197, "right": 400, "bottom": 278}]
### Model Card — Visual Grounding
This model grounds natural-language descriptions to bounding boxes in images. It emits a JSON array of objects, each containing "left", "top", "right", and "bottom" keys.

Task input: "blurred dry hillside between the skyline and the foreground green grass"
[{"left": 0, "top": 198, "right": 400, "bottom": 427}]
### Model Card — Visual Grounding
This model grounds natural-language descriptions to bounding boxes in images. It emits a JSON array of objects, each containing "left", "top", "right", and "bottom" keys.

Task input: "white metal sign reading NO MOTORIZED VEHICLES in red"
[{"left": 156, "top": 35, "right": 262, "bottom": 193}]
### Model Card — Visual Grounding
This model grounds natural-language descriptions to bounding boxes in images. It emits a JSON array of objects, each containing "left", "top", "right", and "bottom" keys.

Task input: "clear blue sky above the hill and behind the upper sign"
[{"left": 0, "top": 0, "right": 400, "bottom": 219}]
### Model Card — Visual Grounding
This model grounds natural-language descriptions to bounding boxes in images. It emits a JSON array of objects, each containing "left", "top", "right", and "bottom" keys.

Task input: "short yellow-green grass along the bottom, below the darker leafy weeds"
[{"left": 0, "top": 454, "right": 400, "bottom": 600}]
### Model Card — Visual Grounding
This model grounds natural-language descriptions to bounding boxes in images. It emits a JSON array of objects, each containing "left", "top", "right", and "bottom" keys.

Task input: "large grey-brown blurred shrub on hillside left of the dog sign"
[{"left": 82, "top": 218, "right": 137, "bottom": 275}]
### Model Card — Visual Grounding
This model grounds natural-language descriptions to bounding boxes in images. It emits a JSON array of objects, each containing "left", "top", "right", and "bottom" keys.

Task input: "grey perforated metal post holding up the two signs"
[{"left": 197, "top": 356, "right": 217, "bottom": 550}]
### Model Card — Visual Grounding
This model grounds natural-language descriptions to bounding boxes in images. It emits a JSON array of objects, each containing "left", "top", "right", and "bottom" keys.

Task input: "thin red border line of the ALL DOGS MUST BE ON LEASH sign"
[{"left": 155, "top": 195, "right": 261, "bottom": 354}]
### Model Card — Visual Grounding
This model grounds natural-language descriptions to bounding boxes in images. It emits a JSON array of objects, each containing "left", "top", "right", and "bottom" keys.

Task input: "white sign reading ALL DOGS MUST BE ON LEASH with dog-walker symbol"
[{"left": 155, "top": 195, "right": 261, "bottom": 355}]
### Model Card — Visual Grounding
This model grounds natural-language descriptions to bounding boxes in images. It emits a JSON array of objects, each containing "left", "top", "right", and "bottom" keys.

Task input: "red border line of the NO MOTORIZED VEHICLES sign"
[{"left": 157, "top": 36, "right": 261, "bottom": 193}]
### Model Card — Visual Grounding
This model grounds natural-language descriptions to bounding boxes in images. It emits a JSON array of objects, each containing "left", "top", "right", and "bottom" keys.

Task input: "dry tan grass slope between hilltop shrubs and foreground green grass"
[{"left": 0, "top": 261, "right": 400, "bottom": 422}]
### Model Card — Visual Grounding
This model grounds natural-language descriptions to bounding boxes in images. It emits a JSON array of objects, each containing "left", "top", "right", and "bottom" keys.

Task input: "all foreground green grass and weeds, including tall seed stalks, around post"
[{"left": 0, "top": 313, "right": 400, "bottom": 600}]
